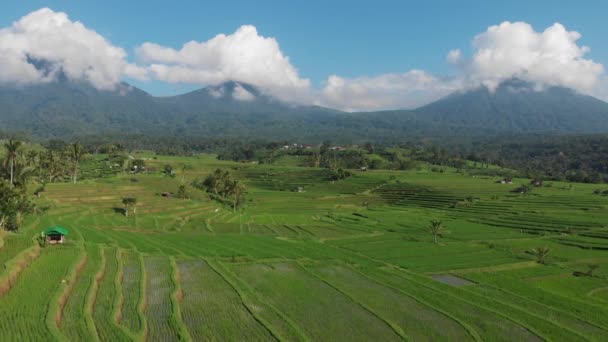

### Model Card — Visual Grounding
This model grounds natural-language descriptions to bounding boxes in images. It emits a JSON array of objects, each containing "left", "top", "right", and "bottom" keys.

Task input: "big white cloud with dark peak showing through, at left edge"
[{"left": 0, "top": 8, "right": 146, "bottom": 89}]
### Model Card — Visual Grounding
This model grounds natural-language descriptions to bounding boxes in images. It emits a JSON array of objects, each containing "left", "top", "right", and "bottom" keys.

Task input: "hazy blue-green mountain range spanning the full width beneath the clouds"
[{"left": 0, "top": 79, "right": 608, "bottom": 142}]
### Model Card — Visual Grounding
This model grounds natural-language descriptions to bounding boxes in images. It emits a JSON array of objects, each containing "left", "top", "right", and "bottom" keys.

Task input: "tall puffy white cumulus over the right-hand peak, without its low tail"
[{"left": 463, "top": 22, "right": 604, "bottom": 94}]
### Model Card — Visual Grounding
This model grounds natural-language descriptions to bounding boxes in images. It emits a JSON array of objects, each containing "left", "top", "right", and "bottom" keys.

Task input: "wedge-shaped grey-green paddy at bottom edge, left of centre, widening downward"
[{"left": 177, "top": 260, "right": 273, "bottom": 341}]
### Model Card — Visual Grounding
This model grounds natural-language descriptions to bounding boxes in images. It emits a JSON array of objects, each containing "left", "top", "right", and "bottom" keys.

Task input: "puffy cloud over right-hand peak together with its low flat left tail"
[{"left": 319, "top": 22, "right": 608, "bottom": 111}]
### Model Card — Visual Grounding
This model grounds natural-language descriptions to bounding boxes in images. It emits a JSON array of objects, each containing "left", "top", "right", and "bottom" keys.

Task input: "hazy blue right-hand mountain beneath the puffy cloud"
[{"left": 414, "top": 80, "right": 608, "bottom": 133}]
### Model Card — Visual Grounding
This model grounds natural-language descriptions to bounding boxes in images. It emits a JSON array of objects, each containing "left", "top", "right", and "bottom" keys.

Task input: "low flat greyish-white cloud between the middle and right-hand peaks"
[{"left": 318, "top": 70, "right": 459, "bottom": 111}]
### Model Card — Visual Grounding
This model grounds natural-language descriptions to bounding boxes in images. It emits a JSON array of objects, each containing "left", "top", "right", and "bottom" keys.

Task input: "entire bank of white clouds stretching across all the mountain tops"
[{"left": 0, "top": 8, "right": 608, "bottom": 111}]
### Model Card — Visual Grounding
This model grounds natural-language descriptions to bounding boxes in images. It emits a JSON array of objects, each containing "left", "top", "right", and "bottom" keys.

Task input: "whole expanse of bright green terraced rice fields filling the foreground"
[{"left": 0, "top": 156, "right": 608, "bottom": 341}]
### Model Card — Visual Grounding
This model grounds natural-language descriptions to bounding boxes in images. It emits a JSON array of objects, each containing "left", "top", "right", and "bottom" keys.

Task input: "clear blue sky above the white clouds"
[{"left": 0, "top": 0, "right": 608, "bottom": 109}]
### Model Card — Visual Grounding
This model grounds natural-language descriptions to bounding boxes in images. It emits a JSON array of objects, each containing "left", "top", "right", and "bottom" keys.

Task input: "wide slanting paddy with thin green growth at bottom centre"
[{"left": 232, "top": 262, "right": 401, "bottom": 341}]
